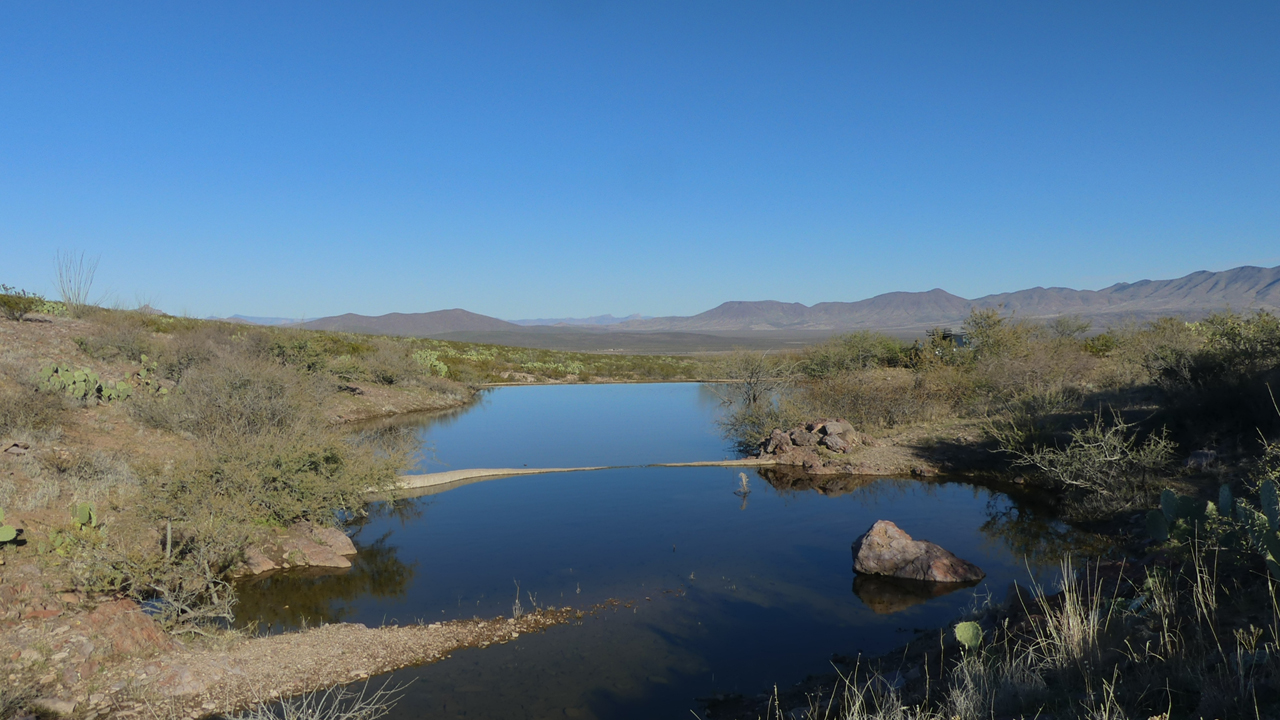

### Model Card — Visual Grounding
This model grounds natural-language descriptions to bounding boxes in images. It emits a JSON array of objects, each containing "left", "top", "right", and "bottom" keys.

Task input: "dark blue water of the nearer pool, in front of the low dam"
[{"left": 240, "top": 468, "right": 1080, "bottom": 719}]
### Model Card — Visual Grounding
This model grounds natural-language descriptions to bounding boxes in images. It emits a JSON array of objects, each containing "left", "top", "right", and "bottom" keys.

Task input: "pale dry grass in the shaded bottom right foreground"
[{"left": 767, "top": 555, "right": 1280, "bottom": 720}]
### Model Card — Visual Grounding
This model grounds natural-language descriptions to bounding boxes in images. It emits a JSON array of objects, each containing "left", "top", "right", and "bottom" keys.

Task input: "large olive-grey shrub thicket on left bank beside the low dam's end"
[{"left": 136, "top": 357, "right": 404, "bottom": 524}]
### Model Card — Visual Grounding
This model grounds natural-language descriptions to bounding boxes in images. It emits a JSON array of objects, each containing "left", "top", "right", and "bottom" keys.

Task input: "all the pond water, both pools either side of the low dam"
[{"left": 239, "top": 384, "right": 1090, "bottom": 719}]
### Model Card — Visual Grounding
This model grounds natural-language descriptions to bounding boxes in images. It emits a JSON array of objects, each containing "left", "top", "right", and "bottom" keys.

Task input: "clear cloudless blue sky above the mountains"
[{"left": 0, "top": 0, "right": 1280, "bottom": 319}]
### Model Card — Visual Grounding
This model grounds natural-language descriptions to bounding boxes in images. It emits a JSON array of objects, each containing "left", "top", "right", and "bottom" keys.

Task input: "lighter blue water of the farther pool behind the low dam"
[{"left": 389, "top": 383, "right": 735, "bottom": 473}]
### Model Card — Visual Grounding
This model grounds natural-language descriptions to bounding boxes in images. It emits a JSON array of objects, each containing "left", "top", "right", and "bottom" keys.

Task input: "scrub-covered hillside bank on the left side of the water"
[{"left": 0, "top": 301, "right": 721, "bottom": 716}]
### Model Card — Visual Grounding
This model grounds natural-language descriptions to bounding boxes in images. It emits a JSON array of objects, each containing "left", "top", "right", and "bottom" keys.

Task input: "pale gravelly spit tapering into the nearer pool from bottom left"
[{"left": 0, "top": 593, "right": 586, "bottom": 719}]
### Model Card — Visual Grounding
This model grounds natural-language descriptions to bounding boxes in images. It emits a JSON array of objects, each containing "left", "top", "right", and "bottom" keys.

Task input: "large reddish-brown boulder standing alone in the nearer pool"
[{"left": 854, "top": 520, "right": 987, "bottom": 583}]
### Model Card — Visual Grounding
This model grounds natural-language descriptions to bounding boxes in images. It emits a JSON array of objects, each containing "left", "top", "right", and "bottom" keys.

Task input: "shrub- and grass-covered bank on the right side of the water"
[{"left": 730, "top": 304, "right": 1280, "bottom": 720}]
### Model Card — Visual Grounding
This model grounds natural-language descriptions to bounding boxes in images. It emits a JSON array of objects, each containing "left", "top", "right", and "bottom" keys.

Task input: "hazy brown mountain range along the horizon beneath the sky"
[{"left": 244, "top": 266, "right": 1280, "bottom": 338}]
